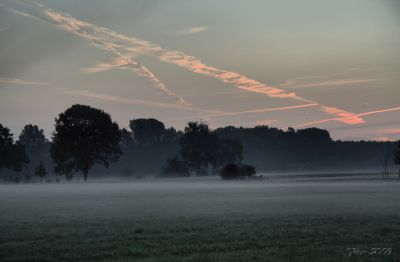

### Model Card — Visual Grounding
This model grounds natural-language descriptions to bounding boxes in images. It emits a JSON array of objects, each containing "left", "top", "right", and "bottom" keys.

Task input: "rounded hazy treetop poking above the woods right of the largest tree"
[{"left": 129, "top": 118, "right": 165, "bottom": 144}]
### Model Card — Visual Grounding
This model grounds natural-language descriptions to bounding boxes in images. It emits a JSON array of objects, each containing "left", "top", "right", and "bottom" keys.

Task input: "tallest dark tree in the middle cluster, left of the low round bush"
[{"left": 179, "top": 122, "right": 218, "bottom": 175}]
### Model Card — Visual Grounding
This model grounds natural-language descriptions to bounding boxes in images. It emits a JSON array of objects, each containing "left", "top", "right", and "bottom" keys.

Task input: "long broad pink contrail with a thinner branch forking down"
[{"left": 10, "top": 1, "right": 364, "bottom": 124}]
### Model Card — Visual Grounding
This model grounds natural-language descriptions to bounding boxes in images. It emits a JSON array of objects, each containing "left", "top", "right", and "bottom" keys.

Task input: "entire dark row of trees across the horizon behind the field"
[{"left": 0, "top": 105, "right": 400, "bottom": 182}]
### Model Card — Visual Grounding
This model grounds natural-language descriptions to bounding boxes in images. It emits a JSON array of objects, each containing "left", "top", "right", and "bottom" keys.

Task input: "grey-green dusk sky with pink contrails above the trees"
[{"left": 0, "top": 0, "right": 400, "bottom": 141}]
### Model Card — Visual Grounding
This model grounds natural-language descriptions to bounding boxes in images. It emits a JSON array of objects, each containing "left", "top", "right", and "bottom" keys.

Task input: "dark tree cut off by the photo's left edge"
[{"left": 0, "top": 124, "right": 29, "bottom": 171}]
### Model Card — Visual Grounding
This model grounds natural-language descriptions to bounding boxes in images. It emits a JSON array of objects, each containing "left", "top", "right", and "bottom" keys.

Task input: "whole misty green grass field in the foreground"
[{"left": 0, "top": 176, "right": 400, "bottom": 262}]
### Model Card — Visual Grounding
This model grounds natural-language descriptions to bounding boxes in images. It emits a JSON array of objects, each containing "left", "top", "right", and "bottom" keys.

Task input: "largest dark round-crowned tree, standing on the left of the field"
[{"left": 51, "top": 105, "right": 122, "bottom": 182}]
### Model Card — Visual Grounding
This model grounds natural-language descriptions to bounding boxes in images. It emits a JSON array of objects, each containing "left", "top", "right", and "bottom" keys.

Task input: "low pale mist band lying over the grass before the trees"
[{"left": 0, "top": 175, "right": 400, "bottom": 221}]
